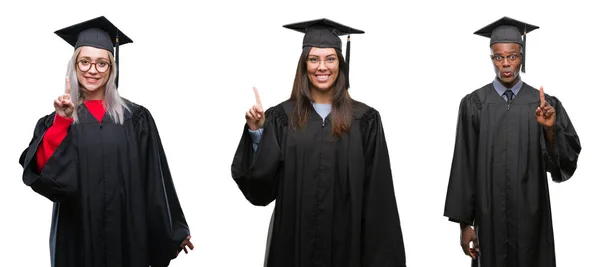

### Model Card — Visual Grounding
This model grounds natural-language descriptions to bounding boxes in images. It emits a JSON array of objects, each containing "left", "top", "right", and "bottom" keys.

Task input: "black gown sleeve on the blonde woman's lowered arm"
[{"left": 133, "top": 107, "right": 190, "bottom": 267}]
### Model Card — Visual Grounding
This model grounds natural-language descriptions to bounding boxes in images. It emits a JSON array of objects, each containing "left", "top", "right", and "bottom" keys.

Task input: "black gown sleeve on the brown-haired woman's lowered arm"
[{"left": 360, "top": 109, "right": 406, "bottom": 267}]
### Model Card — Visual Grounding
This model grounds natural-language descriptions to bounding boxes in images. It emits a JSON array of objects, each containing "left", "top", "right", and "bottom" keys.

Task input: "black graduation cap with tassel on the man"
[{"left": 474, "top": 17, "right": 540, "bottom": 72}]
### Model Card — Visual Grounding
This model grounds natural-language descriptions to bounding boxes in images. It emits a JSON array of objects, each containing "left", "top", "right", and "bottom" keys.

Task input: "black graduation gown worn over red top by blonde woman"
[{"left": 19, "top": 102, "right": 189, "bottom": 267}]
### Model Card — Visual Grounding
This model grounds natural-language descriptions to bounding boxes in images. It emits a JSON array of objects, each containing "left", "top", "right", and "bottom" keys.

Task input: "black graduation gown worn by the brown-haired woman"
[{"left": 231, "top": 101, "right": 405, "bottom": 267}]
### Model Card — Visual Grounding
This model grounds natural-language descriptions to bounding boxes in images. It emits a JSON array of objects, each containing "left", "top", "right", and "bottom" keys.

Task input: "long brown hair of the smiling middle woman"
[{"left": 290, "top": 47, "right": 352, "bottom": 137}]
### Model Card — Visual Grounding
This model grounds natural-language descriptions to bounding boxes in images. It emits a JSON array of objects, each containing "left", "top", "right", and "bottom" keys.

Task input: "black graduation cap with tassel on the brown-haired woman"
[{"left": 283, "top": 18, "right": 365, "bottom": 88}]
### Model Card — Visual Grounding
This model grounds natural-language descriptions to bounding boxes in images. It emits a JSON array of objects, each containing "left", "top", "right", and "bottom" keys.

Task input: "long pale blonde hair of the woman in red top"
[{"left": 67, "top": 47, "right": 129, "bottom": 124}]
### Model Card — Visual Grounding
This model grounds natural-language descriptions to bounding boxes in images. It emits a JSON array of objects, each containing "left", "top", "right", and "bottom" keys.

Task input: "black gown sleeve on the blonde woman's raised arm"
[{"left": 19, "top": 112, "right": 78, "bottom": 202}]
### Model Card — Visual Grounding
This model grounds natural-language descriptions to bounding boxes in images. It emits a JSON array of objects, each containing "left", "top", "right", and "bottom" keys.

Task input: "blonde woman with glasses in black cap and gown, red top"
[{"left": 19, "top": 17, "right": 194, "bottom": 267}]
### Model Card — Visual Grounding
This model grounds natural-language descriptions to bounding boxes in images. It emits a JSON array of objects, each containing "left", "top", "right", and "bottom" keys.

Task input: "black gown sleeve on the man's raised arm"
[{"left": 542, "top": 95, "right": 581, "bottom": 182}]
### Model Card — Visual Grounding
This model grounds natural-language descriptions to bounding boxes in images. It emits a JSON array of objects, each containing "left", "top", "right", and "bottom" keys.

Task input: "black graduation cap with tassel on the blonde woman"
[{"left": 54, "top": 16, "right": 133, "bottom": 87}]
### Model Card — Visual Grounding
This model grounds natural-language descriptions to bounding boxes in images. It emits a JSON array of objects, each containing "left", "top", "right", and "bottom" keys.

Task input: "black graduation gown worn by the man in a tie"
[{"left": 444, "top": 83, "right": 581, "bottom": 267}]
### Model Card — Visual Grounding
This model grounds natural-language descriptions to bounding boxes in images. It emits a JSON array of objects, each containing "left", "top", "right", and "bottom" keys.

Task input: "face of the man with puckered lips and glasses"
[{"left": 492, "top": 43, "right": 521, "bottom": 88}]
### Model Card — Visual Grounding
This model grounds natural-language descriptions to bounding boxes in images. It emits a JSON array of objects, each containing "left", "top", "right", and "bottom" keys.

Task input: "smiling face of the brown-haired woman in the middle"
[{"left": 306, "top": 47, "right": 340, "bottom": 92}]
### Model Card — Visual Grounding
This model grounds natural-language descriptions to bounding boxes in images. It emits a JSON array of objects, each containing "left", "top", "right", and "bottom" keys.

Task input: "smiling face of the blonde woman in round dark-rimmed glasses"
[{"left": 76, "top": 46, "right": 111, "bottom": 94}]
